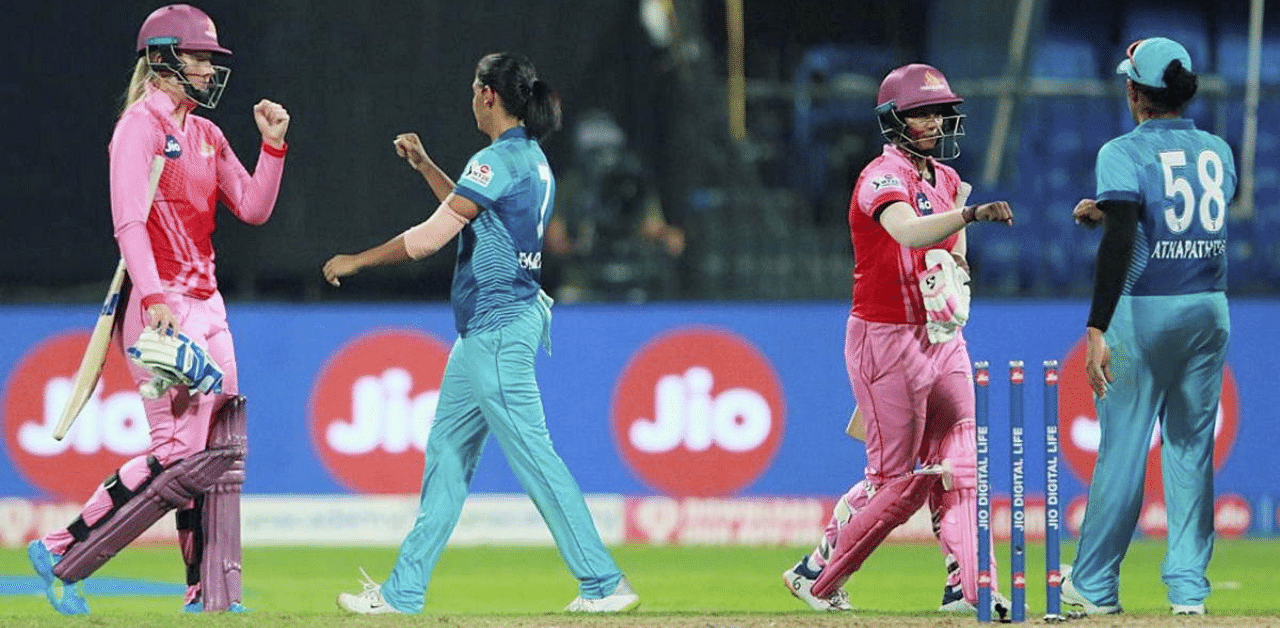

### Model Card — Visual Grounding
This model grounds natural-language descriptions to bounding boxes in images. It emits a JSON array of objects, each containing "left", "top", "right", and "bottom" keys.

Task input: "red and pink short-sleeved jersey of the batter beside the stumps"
[{"left": 849, "top": 145, "right": 960, "bottom": 325}]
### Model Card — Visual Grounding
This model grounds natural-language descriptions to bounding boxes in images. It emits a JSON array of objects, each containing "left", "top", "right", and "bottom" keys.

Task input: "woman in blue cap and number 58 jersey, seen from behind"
[{"left": 1062, "top": 37, "right": 1236, "bottom": 615}]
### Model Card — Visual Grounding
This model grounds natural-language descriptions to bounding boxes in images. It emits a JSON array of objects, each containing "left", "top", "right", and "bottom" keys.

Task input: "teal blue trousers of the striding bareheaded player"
[{"left": 383, "top": 302, "right": 622, "bottom": 613}]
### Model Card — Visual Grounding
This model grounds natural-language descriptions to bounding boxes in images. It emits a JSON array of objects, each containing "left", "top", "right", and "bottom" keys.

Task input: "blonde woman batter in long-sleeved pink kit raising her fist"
[{"left": 28, "top": 4, "right": 289, "bottom": 614}]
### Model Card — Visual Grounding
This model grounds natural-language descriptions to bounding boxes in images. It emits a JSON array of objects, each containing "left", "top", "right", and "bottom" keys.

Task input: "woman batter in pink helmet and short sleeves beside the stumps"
[{"left": 782, "top": 64, "right": 1014, "bottom": 614}]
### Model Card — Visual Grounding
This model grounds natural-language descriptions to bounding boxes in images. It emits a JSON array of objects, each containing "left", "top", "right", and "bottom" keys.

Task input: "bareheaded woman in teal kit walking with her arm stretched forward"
[{"left": 324, "top": 52, "right": 640, "bottom": 614}]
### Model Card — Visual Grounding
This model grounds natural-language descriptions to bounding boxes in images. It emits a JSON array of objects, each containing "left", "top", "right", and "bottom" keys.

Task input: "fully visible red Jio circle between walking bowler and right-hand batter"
[{"left": 611, "top": 327, "right": 786, "bottom": 498}]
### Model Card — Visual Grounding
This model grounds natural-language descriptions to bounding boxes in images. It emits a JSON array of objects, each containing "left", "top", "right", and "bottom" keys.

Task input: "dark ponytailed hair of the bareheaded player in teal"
[{"left": 476, "top": 52, "right": 561, "bottom": 138}]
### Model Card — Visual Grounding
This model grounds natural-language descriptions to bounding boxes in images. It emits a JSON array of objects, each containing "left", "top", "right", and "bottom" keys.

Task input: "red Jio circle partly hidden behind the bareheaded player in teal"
[{"left": 308, "top": 330, "right": 449, "bottom": 494}]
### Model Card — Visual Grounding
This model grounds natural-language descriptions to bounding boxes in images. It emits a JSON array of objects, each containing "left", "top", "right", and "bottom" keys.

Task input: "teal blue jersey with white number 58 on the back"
[{"left": 1097, "top": 118, "right": 1236, "bottom": 295}]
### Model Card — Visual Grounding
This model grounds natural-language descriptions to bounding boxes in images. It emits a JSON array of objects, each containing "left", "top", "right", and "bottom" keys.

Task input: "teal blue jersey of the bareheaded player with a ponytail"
[{"left": 451, "top": 127, "right": 556, "bottom": 336}]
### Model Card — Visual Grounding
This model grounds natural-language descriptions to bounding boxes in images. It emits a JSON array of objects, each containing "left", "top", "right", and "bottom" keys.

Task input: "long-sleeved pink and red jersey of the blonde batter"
[{"left": 109, "top": 87, "right": 287, "bottom": 307}]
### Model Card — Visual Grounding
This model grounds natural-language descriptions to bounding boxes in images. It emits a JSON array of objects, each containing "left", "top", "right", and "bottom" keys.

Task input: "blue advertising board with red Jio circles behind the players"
[{"left": 0, "top": 299, "right": 1280, "bottom": 542}]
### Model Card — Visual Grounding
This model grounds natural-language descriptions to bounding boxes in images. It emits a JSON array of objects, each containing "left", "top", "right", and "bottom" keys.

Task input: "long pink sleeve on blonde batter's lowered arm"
[{"left": 108, "top": 116, "right": 164, "bottom": 307}]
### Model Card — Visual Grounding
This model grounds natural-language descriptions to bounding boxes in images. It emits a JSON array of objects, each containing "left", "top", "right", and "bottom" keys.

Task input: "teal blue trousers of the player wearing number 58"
[{"left": 1071, "top": 293, "right": 1231, "bottom": 606}]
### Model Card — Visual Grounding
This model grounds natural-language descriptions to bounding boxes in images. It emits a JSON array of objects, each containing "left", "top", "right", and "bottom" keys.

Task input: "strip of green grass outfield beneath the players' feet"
[{"left": 0, "top": 540, "right": 1280, "bottom": 628}]
